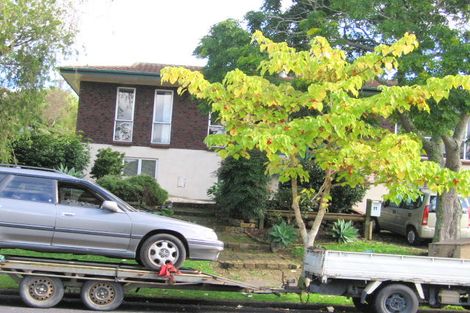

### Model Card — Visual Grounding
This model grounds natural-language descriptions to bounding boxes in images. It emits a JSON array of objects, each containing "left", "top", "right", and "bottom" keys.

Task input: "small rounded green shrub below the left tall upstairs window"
[{"left": 90, "top": 148, "right": 124, "bottom": 179}]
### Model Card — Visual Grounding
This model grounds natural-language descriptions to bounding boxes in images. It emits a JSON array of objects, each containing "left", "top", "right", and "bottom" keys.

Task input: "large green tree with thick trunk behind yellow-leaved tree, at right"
[{"left": 247, "top": 0, "right": 470, "bottom": 241}]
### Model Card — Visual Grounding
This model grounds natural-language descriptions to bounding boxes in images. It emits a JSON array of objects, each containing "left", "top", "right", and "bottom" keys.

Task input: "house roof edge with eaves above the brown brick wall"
[{"left": 59, "top": 63, "right": 202, "bottom": 94}]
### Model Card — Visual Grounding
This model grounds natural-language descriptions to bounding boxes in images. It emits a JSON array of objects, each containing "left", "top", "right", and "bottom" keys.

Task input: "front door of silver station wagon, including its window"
[{"left": 52, "top": 181, "right": 131, "bottom": 252}]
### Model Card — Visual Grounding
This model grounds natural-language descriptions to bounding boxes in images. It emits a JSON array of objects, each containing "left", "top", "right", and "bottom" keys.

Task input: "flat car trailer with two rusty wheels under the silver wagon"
[{"left": 0, "top": 256, "right": 275, "bottom": 311}]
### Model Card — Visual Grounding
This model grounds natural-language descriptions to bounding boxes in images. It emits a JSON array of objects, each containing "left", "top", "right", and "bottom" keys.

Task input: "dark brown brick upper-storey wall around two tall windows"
[{"left": 77, "top": 82, "right": 208, "bottom": 150}]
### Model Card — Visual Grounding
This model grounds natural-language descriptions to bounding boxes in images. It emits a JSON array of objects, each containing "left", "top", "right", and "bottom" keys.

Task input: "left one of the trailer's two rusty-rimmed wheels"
[{"left": 20, "top": 276, "right": 64, "bottom": 308}]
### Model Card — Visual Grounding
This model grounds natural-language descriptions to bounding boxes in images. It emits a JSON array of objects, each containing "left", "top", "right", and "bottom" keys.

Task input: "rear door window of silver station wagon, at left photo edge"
[{"left": 0, "top": 175, "right": 55, "bottom": 203}]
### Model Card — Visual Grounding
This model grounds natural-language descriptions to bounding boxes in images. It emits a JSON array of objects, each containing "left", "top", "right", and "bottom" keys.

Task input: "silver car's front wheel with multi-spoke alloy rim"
[{"left": 140, "top": 234, "right": 186, "bottom": 270}]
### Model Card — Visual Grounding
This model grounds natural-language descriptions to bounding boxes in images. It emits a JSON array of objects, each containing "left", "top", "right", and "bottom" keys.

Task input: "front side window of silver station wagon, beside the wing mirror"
[{"left": 59, "top": 182, "right": 104, "bottom": 208}]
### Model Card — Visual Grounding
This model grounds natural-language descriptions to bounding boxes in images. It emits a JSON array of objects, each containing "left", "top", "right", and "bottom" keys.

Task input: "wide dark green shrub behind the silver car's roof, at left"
[{"left": 12, "top": 130, "right": 90, "bottom": 173}]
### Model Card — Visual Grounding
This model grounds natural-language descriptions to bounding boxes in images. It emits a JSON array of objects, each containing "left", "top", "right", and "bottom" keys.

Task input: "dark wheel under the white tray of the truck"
[{"left": 374, "top": 284, "right": 419, "bottom": 313}]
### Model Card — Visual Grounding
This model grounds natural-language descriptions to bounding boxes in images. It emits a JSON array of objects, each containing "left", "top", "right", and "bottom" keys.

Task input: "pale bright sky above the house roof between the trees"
[{"left": 66, "top": 0, "right": 262, "bottom": 66}]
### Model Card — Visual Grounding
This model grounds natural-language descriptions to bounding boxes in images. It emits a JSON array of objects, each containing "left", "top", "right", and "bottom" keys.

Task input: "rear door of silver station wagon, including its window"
[{"left": 0, "top": 174, "right": 56, "bottom": 247}]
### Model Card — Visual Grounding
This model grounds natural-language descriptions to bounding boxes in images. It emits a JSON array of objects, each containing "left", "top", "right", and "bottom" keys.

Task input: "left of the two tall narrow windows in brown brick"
[{"left": 114, "top": 87, "right": 135, "bottom": 142}]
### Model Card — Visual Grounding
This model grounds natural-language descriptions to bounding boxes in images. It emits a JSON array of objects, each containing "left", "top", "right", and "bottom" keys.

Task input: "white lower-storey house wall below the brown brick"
[{"left": 89, "top": 144, "right": 221, "bottom": 201}]
